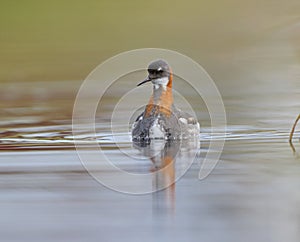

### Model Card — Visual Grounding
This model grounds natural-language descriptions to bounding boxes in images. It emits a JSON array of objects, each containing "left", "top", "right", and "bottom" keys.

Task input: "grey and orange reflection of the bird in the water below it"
[{"left": 134, "top": 138, "right": 200, "bottom": 215}]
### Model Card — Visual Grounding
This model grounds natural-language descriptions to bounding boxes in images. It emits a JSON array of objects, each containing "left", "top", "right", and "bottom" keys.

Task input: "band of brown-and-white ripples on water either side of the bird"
[{"left": 0, "top": 121, "right": 297, "bottom": 150}]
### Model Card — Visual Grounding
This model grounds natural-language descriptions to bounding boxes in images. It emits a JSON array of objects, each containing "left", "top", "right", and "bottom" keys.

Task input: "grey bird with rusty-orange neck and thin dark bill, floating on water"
[{"left": 132, "top": 60, "right": 200, "bottom": 142}]
